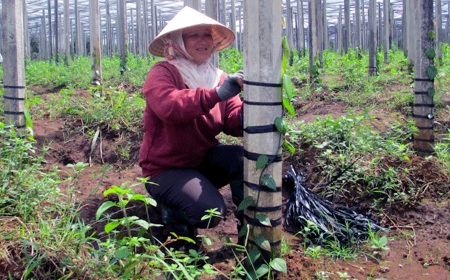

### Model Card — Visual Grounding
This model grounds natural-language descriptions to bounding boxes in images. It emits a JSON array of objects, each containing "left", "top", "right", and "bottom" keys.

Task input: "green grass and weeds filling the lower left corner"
[{"left": 0, "top": 129, "right": 110, "bottom": 279}]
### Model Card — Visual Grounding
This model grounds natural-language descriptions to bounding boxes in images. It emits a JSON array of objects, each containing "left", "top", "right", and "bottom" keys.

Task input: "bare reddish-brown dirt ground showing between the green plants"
[{"left": 14, "top": 91, "right": 450, "bottom": 280}]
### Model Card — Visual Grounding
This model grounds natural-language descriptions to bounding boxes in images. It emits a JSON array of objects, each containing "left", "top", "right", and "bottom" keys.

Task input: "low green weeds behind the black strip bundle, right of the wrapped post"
[{"left": 289, "top": 112, "right": 418, "bottom": 208}]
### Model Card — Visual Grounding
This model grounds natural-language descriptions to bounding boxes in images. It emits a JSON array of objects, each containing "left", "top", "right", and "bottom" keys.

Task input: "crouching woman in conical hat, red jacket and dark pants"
[{"left": 139, "top": 7, "right": 243, "bottom": 246}]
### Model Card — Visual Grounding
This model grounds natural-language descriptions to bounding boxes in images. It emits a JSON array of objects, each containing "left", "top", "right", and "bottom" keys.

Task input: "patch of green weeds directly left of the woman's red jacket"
[{"left": 34, "top": 87, "right": 145, "bottom": 161}]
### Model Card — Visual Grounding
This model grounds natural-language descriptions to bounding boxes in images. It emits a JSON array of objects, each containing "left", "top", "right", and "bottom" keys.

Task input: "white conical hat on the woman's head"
[{"left": 148, "top": 6, "right": 235, "bottom": 57}]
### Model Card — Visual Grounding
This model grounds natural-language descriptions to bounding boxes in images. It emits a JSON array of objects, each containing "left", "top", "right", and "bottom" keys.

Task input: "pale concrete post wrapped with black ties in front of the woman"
[{"left": 244, "top": 0, "right": 283, "bottom": 260}]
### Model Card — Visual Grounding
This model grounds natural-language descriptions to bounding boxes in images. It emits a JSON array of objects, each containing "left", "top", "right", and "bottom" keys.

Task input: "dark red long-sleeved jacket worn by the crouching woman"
[{"left": 139, "top": 61, "right": 242, "bottom": 178}]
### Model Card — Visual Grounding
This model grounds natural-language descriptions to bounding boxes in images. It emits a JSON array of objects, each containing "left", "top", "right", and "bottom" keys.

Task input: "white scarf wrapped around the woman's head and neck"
[{"left": 165, "top": 31, "right": 223, "bottom": 89}]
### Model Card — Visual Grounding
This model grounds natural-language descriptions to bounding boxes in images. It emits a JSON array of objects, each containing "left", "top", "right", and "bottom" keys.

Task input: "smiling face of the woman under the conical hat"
[{"left": 183, "top": 26, "right": 213, "bottom": 64}]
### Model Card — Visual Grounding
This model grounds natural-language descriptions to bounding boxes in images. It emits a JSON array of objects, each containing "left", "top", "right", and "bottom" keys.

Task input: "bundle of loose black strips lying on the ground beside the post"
[{"left": 283, "top": 165, "right": 385, "bottom": 244}]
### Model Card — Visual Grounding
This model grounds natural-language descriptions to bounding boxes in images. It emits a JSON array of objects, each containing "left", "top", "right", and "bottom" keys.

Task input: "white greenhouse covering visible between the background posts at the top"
[{"left": 0, "top": 0, "right": 450, "bottom": 59}]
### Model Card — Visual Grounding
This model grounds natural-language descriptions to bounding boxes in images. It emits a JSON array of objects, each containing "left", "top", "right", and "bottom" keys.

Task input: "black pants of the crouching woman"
[{"left": 146, "top": 144, "right": 244, "bottom": 228}]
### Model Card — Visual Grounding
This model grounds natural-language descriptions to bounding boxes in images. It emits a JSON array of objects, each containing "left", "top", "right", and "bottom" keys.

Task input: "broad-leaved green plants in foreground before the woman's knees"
[{"left": 91, "top": 183, "right": 225, "bottom": 279}]
